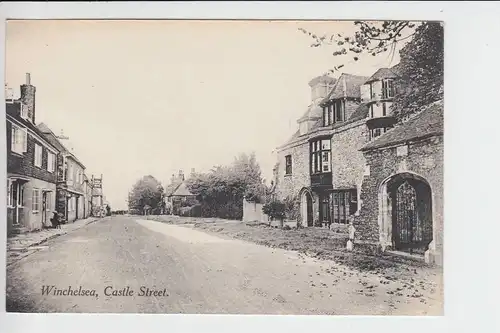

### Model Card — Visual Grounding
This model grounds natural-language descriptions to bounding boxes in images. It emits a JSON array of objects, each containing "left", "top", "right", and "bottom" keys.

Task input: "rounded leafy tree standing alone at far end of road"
[{"left": 128, "top": 175, "right": 164, "bottom": 212}]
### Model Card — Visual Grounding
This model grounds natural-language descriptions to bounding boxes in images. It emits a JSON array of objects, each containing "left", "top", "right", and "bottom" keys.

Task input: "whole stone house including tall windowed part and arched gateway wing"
[{"left": 275, "top": 66, "right": 443, "bottom": 264}]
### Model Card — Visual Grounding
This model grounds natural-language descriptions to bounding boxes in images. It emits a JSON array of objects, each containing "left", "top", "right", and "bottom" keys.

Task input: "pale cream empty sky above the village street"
[{"left": 6, "top": 20, "right": 408, "bottom": 209}]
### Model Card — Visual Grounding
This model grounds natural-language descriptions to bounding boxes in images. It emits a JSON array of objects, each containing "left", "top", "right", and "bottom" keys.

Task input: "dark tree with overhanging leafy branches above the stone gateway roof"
[{"left": 299, "top": 21, "right": 444, "bottom": 120}]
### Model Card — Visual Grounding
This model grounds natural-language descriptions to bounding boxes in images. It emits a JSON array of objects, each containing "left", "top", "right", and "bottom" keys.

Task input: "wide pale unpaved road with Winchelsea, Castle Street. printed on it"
[{"left": 7, "top": 216, "right": 442, "bottom": 315}]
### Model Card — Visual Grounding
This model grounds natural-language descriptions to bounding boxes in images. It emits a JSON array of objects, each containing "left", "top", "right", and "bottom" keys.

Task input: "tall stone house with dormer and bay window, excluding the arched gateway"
[{"left": 275, "top": 74, "right": 368, "bottom": 226}]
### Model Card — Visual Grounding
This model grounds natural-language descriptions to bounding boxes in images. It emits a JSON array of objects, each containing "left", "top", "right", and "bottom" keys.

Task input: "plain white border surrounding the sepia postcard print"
[{"left": 0, "top": 1, "right": 500, "bottom": 333}]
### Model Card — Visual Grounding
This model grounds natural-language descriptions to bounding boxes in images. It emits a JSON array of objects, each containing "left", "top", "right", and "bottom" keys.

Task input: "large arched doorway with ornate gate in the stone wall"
[{"left": 379, "top": 173, "right": 433, "bottom": 255}]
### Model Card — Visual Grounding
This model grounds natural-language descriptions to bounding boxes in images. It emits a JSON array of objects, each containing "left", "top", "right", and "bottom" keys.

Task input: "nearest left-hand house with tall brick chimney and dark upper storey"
[{"left": 6, "top": 74, "right": 59, "bottom": 234}]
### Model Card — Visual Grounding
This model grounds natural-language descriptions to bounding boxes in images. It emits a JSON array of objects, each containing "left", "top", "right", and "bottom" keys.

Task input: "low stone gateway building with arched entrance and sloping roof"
[{"left": 354, "top": 101, "right": 444, "bottom": 265}]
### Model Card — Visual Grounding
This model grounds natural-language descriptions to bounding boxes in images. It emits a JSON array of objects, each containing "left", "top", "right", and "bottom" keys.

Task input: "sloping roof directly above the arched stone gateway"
[{"left": 361, "top": 100, "right": 444, "bottom": 151}]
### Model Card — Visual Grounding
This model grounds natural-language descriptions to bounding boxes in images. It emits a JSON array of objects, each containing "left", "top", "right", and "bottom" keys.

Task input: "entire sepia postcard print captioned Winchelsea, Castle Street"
[{"left": 4, "top": 19, "right": 445, "bottom": 316}]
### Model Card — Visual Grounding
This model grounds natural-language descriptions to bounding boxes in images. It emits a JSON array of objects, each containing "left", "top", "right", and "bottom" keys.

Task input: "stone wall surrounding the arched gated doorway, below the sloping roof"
[{"left": 354, "top": 136, "right": 444, "bottom": 264}]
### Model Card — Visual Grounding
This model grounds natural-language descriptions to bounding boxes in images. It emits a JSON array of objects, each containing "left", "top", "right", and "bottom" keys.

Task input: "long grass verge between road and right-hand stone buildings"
[{"left": 145, "top": 215, "right": 442, "bottom": 276}]
